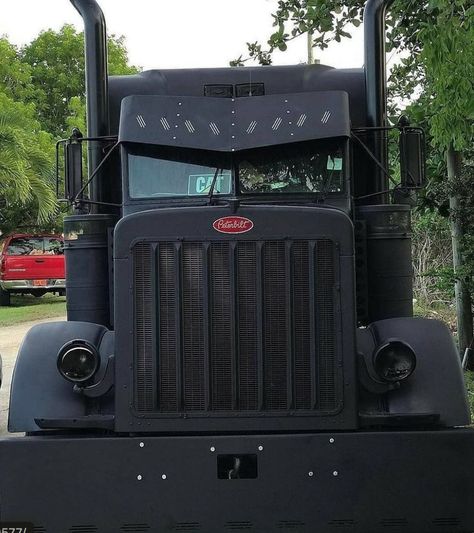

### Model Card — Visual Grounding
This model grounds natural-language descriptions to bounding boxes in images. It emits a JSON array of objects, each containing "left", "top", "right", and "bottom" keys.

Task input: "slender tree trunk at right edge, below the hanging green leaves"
[{"left": 446, "top": 147, "right": 473, "bottom": 358}]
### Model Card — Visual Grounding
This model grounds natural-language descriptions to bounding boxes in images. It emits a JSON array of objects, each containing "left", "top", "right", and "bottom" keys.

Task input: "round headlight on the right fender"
[{"left": 374, "top": 341, "right": 416, "bottom": 383}]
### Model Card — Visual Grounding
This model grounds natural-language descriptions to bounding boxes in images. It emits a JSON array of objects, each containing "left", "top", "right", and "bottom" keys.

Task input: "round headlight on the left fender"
[{"left": 58, "top": 340, "right": 100, "bottom": 383}]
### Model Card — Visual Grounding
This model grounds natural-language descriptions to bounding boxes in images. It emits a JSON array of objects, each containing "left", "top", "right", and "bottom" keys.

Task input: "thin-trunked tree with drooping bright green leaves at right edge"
[{"left": 419, "top": 0, "right": 474, "bottom": 351}]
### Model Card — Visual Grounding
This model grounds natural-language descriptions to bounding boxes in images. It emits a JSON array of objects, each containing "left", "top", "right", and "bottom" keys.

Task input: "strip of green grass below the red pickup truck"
[{"left": 0, "top": 293, "right": 66, "bottom": 326}]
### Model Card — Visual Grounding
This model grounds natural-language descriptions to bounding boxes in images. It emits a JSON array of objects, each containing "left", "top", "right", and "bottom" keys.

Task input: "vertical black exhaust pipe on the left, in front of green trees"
[{"left": 70, "top": 0, "right": 109, "bottom": 213}]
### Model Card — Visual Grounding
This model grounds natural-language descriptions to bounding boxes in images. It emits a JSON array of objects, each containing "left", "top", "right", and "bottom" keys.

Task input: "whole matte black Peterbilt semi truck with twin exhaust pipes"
[{"left": 0, "top": 0, "right": 474, "bottom": 533}]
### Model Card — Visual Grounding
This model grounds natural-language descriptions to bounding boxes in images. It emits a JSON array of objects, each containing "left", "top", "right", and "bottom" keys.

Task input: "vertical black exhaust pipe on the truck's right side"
[{"left": 364, "top": 0, "right": 394, "bottom": 198}]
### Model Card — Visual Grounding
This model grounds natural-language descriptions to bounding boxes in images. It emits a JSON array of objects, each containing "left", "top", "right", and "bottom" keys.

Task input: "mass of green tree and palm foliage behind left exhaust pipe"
[{"left": 0, "top": 25, "right": 138, "bottom": 234}]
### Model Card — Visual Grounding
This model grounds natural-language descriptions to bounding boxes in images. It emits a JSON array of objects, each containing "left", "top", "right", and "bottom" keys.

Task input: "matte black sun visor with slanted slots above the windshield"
[{"left": 119, "top": 91, "right": 350, "bottom": 152}]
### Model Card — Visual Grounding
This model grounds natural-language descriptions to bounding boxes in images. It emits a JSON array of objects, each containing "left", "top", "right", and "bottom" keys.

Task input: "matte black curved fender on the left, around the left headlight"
[{"left": 8, "top": 322, "right": 114, "bottom": 433}]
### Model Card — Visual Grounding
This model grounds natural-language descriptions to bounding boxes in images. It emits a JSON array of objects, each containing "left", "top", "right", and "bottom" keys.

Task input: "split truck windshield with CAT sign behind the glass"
[{"left": 127, "top": 141, "right": 345, "bottom": 199}]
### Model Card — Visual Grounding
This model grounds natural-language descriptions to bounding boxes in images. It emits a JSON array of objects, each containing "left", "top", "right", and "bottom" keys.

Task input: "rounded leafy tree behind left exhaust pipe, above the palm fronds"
[{"left": 20, "top": 24, "right": 139, "bottom": 137}]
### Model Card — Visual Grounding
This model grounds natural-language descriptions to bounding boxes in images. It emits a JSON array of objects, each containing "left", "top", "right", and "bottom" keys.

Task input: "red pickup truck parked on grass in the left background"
[{"left": 0, "top": 234, "right": 66, "bottom": 305}]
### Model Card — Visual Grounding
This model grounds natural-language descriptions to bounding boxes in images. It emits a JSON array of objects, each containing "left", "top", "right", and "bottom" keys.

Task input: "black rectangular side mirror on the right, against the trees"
[{"left": 400, "top": 128, "right": 426, "bottom": 189}]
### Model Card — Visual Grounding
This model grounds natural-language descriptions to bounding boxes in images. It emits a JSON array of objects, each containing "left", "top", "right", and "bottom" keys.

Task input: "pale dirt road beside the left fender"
[{"left": 0, "top": 317, "right": 65, "bottom": 435}]
